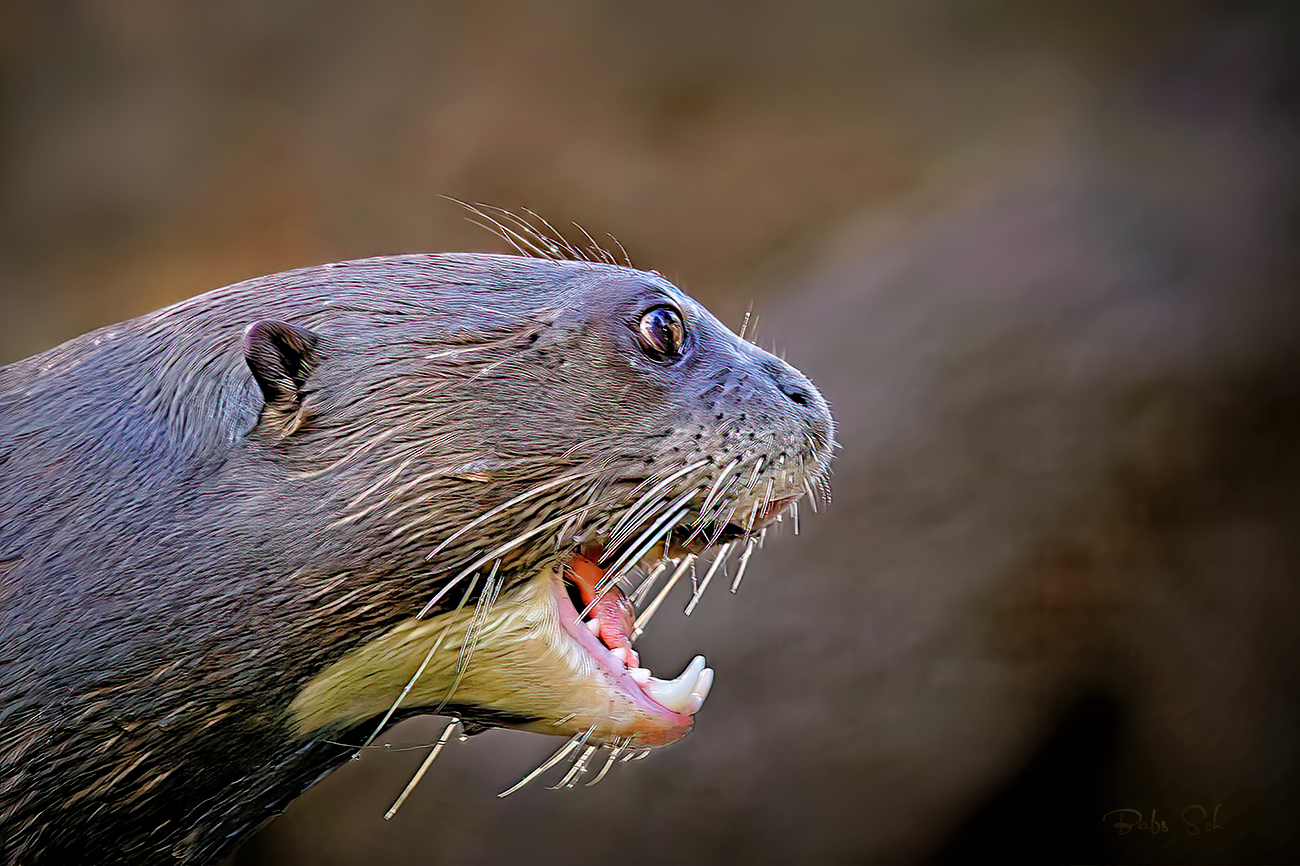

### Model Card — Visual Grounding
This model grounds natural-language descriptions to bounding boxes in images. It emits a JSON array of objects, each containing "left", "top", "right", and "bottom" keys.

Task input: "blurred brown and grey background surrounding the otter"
[{"left": 0, "top": 0, "right": 1300, "bottom": 866}]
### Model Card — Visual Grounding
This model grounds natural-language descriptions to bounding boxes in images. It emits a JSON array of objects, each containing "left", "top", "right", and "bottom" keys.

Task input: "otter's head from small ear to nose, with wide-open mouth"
[{"left": 260, "top": 250, "right": 832, "bottom": 749}]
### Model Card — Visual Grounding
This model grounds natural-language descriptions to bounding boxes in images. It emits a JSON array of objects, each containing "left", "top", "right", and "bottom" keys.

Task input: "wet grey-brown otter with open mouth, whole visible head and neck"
[{"left": 0, "top": 245, "right": 833, "bottom": 863}]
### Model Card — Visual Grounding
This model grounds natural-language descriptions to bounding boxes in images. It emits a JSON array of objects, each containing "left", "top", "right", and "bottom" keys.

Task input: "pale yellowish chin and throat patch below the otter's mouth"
[{"left": 289, "top": 567, "right": 692, "bottom": 748}]
